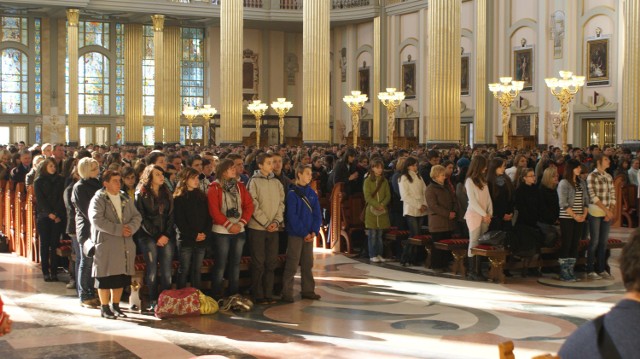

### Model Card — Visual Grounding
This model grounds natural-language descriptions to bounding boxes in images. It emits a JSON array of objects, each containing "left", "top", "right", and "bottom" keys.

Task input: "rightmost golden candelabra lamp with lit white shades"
[{"left": 544, "top": 71, "right": 584, "bottom": 154}]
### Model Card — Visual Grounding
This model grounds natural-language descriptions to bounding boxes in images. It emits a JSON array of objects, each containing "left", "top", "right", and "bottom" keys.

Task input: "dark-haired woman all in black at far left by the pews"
[{"left": 33, "top": 158, "right": 66, "bottom": 282}]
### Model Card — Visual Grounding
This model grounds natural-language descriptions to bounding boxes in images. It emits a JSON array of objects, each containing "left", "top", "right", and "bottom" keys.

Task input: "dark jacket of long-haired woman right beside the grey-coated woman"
[{"left": 136, "top": 187, "right": 174, "bottom": 240}]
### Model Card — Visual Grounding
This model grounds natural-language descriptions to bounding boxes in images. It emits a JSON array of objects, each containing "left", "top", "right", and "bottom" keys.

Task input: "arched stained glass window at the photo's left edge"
[{"left": 0, "top": 48, "right": 29, "bottom": 114}]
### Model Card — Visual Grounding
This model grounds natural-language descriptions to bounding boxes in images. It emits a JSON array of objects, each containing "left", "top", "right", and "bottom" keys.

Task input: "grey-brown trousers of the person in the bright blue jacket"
[{"left": 282, "top": 236, "right": 316, "bottom": 298}]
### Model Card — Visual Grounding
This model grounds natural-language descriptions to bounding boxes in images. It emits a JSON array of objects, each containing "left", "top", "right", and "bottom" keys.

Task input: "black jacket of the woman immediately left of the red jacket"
[{"left": 173, "top": 189, "right": 211, "bottom": 247}]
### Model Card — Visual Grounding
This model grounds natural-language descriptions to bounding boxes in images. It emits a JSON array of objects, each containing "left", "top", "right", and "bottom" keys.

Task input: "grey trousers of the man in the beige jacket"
[{"left": 249, "top": 229, "right": 279, "bottom": 299}]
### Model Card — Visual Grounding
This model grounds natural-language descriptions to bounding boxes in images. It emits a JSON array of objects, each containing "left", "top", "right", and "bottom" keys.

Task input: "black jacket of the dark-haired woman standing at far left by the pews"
[{"left": 33, "top": 173, "right": 67, "bottom": 221}]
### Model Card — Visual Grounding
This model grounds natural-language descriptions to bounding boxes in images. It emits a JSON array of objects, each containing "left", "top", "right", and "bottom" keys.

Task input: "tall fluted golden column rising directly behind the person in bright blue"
[{"left": 302, "top": 0, "right": 330, "bottom": 144}]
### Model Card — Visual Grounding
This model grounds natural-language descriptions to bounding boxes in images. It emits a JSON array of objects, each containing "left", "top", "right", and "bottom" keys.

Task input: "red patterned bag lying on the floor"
[{"left": 155, "top": 288, "right": 200, "bottom": 319}]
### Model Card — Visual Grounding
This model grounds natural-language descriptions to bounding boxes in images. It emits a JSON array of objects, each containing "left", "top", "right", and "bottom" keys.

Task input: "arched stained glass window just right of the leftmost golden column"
[{"left": 78, "top": 52, "right": 109, "bottom": 115}]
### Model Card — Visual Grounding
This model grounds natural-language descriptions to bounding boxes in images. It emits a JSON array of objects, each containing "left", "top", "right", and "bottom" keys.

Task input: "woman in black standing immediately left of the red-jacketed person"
[{"left": 173, "top": 167, "right": 211, "bottom": 289}]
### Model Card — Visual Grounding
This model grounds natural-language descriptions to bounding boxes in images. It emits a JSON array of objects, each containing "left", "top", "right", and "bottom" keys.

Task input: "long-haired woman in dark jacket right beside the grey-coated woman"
[{"left": 136, "top": 165, "right": 175, "bottom": 310}]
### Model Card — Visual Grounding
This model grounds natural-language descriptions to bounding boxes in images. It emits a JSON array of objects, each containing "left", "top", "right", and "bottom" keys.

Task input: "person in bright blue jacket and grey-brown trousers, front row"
[{"left": 282, "top": 165, "right": 322, "bottom": 303}]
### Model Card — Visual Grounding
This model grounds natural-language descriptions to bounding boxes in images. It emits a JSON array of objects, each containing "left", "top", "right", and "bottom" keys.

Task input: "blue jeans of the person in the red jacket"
[{"left": 211, "top": 232, "right": 246, "bottom": 299}]
